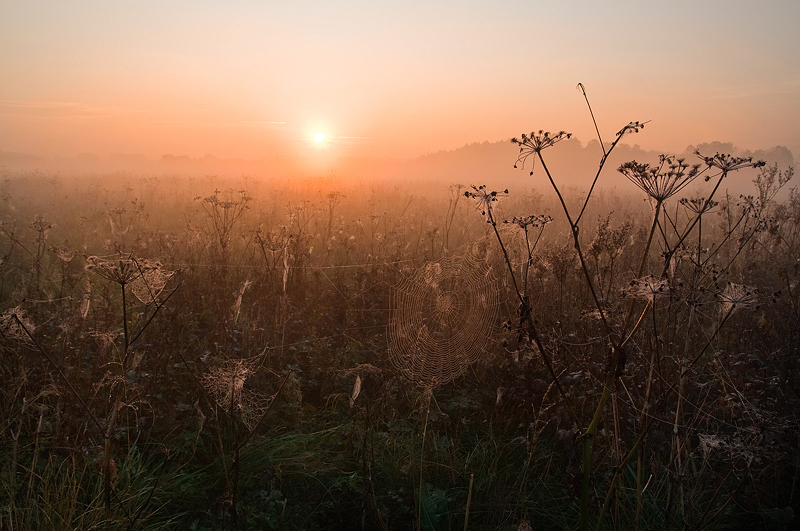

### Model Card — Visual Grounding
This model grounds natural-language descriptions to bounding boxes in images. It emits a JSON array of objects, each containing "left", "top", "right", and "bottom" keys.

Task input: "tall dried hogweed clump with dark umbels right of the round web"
[{"left": 465, "top": 86, "right": 788, "bottom": 530}]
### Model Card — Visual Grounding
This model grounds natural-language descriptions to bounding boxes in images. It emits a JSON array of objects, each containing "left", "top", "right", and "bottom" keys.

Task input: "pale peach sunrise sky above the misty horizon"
[{"left": 0, "top": 0, "right": 800, "bottom": 169}]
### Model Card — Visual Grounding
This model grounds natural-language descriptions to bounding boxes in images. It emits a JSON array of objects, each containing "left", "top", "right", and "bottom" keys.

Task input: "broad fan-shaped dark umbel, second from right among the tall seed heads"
[{"left": 618, "top": 155, "right": 700, "bottom": 203}]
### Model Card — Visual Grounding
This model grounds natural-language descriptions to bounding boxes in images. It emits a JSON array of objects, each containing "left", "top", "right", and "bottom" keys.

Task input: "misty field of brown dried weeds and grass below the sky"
[{"left": 0, "top": 138, "right": 800, "bottom": 531}]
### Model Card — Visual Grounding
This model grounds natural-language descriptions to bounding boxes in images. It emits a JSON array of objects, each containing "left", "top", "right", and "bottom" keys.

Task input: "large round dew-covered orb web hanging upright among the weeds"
[{"left": 389, "top": 256, "right": 500, "bottom": 389}]
